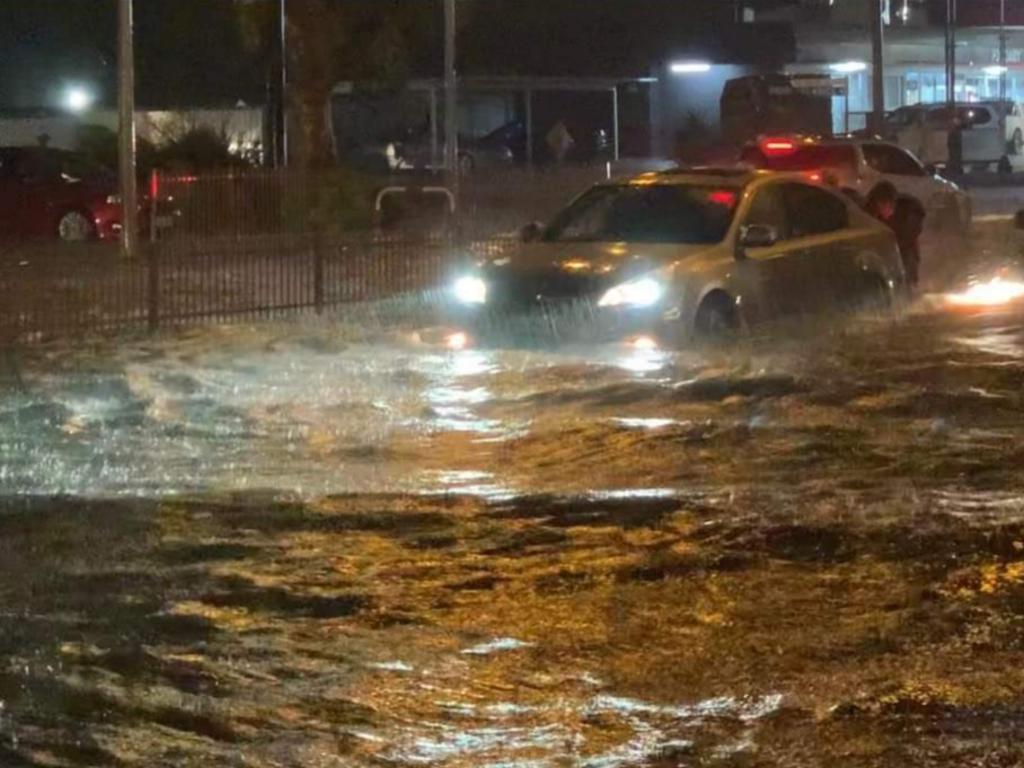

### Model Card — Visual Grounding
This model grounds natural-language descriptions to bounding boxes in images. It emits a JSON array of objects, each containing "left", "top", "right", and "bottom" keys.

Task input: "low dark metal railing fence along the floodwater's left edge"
[{"left": 0, "top": 234, "right": 509, "bottom": 345}]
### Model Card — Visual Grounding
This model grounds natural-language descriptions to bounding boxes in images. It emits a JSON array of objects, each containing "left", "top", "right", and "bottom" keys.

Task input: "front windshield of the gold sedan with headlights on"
[{"left": 544, "top": 184, "right": 739, "bottom": 245}]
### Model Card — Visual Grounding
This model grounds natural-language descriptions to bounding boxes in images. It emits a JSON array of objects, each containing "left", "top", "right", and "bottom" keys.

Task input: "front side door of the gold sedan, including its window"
[{"left": 737, "top": 182, "right": 820, "bottom": 322}]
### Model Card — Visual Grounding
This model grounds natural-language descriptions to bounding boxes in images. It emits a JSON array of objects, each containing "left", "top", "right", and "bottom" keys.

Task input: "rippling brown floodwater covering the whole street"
[{"left": 0, "top": 222, "right": 1024, "bottom": 768}]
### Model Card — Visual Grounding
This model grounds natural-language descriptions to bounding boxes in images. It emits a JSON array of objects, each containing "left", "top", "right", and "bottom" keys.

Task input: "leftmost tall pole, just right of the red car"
[{"left": 118, "top": 0, "right": 137, "bottom": 258}]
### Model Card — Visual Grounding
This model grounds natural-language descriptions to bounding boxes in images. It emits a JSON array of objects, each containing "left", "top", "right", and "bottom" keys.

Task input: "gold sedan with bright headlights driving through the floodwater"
[{"left": 450, "top": 168, "right": 905, "bottom": 342}]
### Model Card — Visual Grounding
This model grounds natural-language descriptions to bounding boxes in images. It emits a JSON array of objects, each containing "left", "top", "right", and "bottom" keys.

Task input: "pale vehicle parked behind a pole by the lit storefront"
[{"left": 886, "top": 101, "right": 1024, "bottom": 171}]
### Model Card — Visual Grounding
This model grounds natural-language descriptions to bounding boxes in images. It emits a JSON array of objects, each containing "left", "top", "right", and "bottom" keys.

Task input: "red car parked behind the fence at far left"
[{"left": 0, "top": 146, "right": 122, "bottom": 243}]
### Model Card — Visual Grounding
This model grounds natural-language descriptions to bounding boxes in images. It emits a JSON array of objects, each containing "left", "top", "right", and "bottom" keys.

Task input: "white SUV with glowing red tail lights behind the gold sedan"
[{"left": 740, "top": 136, "right": 972, "bottom": 233}]
